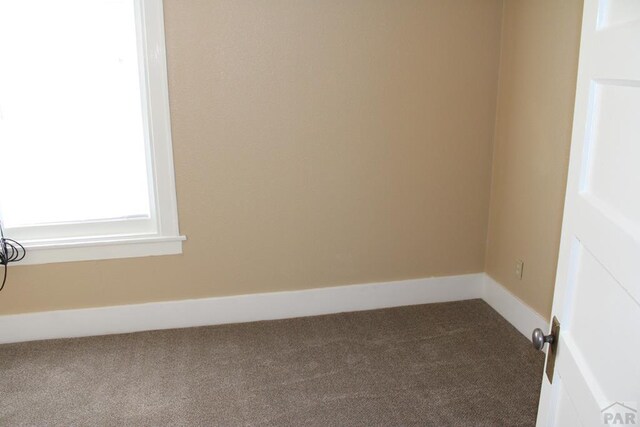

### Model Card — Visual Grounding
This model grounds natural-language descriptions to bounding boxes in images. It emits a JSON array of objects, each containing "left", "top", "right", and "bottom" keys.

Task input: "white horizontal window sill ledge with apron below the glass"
[{"left": 11, "top": 236, "right": 187, "bottom": 266}]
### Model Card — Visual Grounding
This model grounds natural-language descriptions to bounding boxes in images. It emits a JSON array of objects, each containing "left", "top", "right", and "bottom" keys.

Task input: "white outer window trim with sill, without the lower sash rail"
[{"left": 7, "top": 0, "right": 186, "bottom": 266}]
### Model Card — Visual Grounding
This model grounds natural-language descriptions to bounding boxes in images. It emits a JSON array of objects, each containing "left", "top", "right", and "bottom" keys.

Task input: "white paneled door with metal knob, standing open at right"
[{"left": 538, "top": 0, "right": 640, "bottom": 427}]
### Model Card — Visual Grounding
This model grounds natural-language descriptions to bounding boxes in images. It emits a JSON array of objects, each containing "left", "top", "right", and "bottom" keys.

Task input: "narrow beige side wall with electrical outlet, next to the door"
[{"left": 486, "top": 0, "right": 582, "bottom": 316}]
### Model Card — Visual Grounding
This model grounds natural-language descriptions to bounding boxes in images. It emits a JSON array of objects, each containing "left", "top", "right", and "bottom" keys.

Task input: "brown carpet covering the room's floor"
[{"left": 0, "top": 300, "right": 543, "bottom": 426}]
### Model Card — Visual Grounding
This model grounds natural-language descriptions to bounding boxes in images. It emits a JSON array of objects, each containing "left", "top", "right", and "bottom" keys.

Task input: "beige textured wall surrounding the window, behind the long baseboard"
[{"left": 0, "top": 0, "right": 502, "bottom": 313}]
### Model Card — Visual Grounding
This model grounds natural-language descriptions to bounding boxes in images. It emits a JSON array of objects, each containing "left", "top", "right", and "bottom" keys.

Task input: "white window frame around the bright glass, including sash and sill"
[{"left": 5, "top": 0, "right": 186, "bottom": 265}]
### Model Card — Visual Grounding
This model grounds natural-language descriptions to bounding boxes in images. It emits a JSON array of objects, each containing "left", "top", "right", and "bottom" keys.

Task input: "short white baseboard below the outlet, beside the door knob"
[{"left": 482, "top": 274, "right": 549, "bottom": 338}]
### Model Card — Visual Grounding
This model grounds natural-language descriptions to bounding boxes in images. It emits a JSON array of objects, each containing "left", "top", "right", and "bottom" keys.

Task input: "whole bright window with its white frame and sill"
[{"left": 0, "top": 0, "right": 184, "bottom": 263}]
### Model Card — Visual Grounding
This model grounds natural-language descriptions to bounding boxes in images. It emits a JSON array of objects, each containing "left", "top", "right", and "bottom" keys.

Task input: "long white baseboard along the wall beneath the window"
[{"left": 0, "top": 273, "right": 482, "bottom": 343}]
